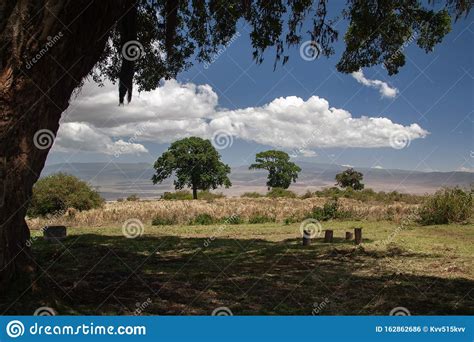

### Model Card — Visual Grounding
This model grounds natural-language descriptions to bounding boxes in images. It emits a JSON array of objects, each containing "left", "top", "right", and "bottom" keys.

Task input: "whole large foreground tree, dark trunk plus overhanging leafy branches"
[{"left": 0, "top": 0, "right": 472, "bottom": 287}]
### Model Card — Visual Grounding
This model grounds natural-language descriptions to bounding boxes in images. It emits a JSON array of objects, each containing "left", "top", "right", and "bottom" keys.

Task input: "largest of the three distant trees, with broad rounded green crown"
[{"left": 152, "top": 137, "right": 232, "bottom": 199}]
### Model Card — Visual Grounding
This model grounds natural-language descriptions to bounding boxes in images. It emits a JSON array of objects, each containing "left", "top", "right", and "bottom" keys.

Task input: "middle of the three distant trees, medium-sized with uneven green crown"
[{"left": 249, "top": 150, "right": 301, "bottom": 189}]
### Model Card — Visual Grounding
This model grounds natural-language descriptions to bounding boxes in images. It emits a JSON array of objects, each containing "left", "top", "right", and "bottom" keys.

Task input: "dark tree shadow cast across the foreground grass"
[{"left": 0, "top": 234, "right": 474, "bottom": 315}]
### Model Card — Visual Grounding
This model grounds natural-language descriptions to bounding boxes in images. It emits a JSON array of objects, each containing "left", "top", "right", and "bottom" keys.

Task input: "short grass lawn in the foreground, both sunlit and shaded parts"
[{"left": 0, "top": 222, "right": 474, "bottom": 315}]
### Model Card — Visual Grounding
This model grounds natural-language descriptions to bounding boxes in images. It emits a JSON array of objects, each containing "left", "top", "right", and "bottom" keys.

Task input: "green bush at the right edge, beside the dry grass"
[{"left": 418, "top": 187, "right": 473, "bottom": 225}]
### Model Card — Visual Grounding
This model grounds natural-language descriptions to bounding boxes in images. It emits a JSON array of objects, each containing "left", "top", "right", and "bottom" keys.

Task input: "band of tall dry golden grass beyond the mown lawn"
[{"left": 27, "top": 197, "right": 417, "bottom": 229}]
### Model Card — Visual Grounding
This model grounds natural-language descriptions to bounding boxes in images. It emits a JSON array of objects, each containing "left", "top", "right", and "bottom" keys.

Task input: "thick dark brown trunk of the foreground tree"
[{"left": 0, "top": 0, "right": 129, "bottom": 292}]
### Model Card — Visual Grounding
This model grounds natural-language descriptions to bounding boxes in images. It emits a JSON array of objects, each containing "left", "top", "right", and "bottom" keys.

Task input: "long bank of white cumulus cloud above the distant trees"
[{"left": 54, "top": 80, "right": 428, "bottom": 156}]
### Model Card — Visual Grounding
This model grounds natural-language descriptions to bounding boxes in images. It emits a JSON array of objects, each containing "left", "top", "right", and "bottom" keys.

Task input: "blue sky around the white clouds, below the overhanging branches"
[{"left": 48, "top": 7, "right": 474, "bottom": 171}]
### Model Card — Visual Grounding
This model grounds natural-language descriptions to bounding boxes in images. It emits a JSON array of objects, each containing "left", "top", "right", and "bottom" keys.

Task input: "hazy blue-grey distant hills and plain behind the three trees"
[{"left": 42, "top": 162, "right": 474, "bottom": 200}]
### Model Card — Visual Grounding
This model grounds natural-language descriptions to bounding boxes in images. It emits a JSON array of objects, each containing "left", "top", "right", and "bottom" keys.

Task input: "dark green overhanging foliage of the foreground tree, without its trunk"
[{"left": 92, "top": 0, "right": 472, "bottom": 102}]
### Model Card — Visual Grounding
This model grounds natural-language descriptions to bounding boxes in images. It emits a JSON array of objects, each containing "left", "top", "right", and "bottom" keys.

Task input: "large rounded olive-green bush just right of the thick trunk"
[{"left": 28, "top": 173, "right": 104, "bottom": 217}]
